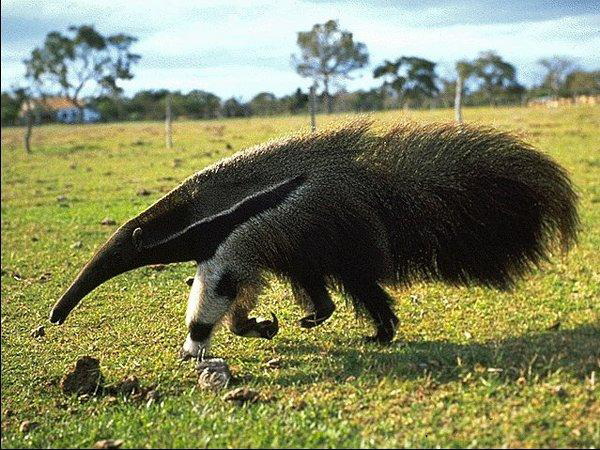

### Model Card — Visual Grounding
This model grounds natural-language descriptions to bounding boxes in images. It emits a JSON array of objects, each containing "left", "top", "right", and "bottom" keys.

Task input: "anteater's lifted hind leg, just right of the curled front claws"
[{"left": 292, "top": 275, "right": 335, "bottom": 328}]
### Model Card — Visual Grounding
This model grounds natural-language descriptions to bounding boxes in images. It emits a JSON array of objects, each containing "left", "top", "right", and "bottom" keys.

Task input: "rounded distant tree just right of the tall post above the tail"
[{"left": 473, "top": 51, "right": 522, "bottom": 105}]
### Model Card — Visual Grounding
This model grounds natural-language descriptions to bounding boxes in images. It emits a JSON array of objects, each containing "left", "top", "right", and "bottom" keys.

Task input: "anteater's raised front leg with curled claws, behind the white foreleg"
[{"left": 226, "top": 286, "right": 279, "bottom": 339}]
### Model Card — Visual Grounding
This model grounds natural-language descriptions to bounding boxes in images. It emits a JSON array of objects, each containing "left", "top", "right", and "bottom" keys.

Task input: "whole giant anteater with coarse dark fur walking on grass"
[{"left": 52, "top": 120, "right": 578, "bottom": 352}]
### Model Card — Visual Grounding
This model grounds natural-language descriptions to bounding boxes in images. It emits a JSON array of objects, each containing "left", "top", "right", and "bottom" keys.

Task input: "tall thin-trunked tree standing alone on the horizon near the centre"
[{"left": 292, "top": 20, "right": 369, "bottom": 113}]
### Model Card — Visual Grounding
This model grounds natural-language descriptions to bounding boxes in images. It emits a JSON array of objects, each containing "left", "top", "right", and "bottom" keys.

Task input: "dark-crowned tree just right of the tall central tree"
[{"left": 373, "top": 56, "right": 439, "bottom": 107}]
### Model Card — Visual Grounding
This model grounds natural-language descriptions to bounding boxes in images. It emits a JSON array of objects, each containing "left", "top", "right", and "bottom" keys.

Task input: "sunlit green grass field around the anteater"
[{"left": 2, "top": 107, "right": 600, "bottom": 448}]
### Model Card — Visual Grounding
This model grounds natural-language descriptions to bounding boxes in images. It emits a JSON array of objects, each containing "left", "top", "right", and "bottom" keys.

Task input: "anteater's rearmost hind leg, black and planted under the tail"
[{"left": 344, "top": 281, "right": 398, "bottom": 343}]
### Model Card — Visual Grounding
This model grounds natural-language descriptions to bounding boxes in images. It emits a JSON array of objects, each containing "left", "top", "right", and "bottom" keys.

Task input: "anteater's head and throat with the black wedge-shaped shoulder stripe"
[{"left": 50, "top": 176, "right": 304, "bottom": 324}]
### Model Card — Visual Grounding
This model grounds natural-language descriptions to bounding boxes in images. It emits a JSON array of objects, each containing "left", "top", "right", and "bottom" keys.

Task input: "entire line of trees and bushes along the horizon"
[{"left": 2, "top": 20, "right": 600, "bottom": 126}]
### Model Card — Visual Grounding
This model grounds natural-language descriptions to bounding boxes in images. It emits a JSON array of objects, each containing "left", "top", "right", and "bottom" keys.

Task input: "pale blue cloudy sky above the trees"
[{"left": 1, "top": 0, "right": 600, "bottom": 100}]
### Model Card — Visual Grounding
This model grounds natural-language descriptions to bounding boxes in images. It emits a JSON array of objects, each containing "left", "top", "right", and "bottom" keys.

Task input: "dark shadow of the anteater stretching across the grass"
[{"left": 268, "top": 324, "right": 600, "bottom": 385}]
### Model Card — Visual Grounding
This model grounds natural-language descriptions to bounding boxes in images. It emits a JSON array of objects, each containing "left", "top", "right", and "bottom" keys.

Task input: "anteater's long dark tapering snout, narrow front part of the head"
[{"left": 50, "top": 226, "right": 143, "bottom": 324}]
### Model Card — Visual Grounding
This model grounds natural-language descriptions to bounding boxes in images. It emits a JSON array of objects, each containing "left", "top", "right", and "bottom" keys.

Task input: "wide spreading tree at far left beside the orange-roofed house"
[{"left": 24, "top": 25, "right": 140, "bottom": 122}]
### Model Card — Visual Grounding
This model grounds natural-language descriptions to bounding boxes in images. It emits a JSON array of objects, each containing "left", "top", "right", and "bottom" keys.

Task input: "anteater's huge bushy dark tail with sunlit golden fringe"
[{"left": 361, "top": 124, "right": 578, "bottom": 288}]
